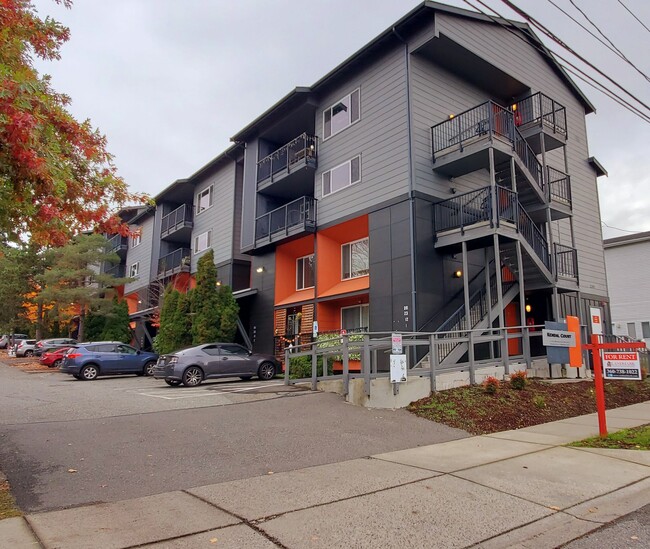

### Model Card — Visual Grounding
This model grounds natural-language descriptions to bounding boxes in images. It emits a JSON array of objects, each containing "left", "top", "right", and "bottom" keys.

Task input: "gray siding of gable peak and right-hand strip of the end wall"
[{"left": 434, "top": 14, "right": 607, "bottom": 296}]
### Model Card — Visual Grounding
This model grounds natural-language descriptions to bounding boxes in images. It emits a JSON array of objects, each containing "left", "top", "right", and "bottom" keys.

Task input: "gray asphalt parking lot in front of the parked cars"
[{"left": 0, "top": 362, "right": 467, "bottom": 512}]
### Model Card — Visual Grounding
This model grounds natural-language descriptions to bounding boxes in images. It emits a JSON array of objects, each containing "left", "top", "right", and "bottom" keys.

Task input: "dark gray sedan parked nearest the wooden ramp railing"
[{"left": 153, "top": 343, "right": 280, "bottom": 387}]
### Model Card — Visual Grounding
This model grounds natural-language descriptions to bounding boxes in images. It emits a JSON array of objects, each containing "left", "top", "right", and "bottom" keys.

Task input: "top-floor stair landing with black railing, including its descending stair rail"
[{"left": 431, "top": 101, "right": 546, "bottom": 203}]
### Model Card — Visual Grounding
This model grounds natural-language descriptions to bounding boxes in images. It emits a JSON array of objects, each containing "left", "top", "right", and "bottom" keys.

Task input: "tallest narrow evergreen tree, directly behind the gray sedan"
[{"left": 192, "top": 249, "right": 221, "bottom": 345}]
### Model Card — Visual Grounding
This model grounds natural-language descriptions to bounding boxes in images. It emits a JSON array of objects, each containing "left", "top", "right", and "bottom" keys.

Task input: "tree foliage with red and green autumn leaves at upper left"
[{"left": 0, "top": 0, "right": 146, "bottom": 246}]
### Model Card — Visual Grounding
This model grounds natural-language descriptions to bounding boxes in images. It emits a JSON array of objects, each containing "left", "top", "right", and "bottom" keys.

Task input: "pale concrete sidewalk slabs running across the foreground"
[{"left": 0, "top": 402, "right": 650, "bottom": 549}]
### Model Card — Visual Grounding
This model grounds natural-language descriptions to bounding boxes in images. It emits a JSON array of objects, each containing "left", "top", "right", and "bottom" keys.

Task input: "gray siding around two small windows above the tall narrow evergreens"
[{"left": 192, "top": 162, "right": 235, "bottom": 272}]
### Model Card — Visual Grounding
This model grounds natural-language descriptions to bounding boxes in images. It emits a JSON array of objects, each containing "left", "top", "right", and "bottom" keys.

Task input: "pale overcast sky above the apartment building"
[{"left": 34, "top": 0, "right": 650, "bottom": 238}]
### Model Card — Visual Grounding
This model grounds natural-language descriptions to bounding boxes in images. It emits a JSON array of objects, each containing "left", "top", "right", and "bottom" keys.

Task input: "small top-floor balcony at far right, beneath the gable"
[{"left": 511, "top": 92, "right": 568, "bottom": 154}]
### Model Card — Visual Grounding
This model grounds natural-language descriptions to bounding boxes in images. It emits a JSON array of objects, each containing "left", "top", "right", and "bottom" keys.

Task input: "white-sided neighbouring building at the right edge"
[{"left": 604, "top": 232, "right": 650, "bottom": 345}]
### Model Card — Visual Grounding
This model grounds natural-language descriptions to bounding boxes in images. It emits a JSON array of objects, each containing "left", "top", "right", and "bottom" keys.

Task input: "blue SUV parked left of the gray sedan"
[{"left": 59, "top": 341, "right": 158, "bottom": 381}]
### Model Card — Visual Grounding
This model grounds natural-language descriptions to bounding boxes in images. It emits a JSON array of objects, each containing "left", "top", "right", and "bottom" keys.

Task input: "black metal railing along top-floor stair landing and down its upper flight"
[{"left": 431, "top": 101, "right": 544, "bottom": 192}]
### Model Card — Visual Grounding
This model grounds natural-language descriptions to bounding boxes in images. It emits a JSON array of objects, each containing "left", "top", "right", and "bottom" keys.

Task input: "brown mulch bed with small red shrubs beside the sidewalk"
[{"left": 408, "top": 379, "right": 650, "bottom": 435}]
